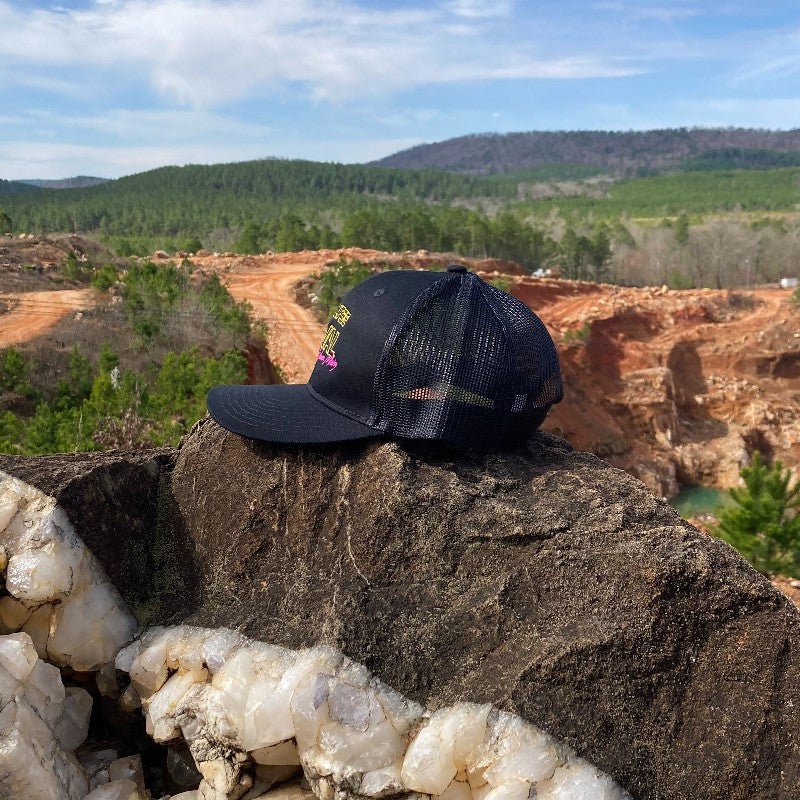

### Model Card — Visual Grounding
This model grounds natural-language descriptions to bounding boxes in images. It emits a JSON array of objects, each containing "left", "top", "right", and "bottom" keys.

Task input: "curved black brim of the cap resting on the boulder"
[{"left": 206, "top": 384, "right": 382, "bottom": 444}]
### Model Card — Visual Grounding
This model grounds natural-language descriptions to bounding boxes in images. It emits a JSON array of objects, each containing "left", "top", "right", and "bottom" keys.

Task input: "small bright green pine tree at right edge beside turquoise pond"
[{"left": 715, "top": 451, "right": 800, "bottom": 577}]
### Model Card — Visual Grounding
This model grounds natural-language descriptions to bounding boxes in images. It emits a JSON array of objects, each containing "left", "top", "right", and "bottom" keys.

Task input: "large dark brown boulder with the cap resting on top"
[{"left": 0, "top": 420, "right": 800, "bottom": 800}]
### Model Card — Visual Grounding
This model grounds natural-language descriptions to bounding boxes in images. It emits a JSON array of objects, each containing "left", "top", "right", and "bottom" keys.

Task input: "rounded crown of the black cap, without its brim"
[{"left": 311, "top": 266, "right": 562, "bottom": 446}]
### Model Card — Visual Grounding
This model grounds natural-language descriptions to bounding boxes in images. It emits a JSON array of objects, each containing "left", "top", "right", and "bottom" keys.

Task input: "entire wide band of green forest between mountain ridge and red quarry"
[{"left": 0, "top": 154, "right": 800, "bottom": 287}]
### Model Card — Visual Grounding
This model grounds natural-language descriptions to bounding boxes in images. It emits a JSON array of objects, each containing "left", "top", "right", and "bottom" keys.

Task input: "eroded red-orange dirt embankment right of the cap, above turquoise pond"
[{"left": 512, "top": 279, "right": 800, "bottom": 495}]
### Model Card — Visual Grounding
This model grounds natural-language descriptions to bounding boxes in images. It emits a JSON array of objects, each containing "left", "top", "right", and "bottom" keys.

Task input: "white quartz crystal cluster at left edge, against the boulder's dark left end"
[{"left": 0, "top": 472, "right": 136, "bottom": 672}]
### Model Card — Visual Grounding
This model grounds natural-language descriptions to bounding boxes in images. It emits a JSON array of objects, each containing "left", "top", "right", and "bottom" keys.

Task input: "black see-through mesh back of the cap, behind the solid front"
[{"left": 370, "top": 273, "right": 562, "bottom": 446}]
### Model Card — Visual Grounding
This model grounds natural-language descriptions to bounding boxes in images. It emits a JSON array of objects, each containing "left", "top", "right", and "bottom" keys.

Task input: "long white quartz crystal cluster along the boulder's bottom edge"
[{"left": 116, "top": 626, "right": 627, "bottom": 800}]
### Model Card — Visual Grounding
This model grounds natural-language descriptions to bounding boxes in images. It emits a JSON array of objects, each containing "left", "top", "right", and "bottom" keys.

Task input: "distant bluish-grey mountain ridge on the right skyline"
[{"left": 372, "top": 128, "right": 800, "bottom": 176}]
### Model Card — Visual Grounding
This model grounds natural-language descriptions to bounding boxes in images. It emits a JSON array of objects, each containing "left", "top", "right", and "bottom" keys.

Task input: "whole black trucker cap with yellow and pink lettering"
[{"left": 207, "top": 265, "right": 563, "bottom": 447}]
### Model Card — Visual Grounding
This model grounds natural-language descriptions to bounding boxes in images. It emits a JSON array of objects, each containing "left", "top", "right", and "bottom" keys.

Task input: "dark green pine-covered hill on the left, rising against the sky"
[{"left": 5, "top": 160, "right": 506, "bottom": 237}]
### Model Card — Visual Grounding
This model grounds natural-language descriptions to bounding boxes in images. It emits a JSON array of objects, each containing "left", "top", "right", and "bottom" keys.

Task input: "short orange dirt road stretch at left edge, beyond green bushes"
[{"left": 0, "top": 289, "right": 97, "bottom": 348}]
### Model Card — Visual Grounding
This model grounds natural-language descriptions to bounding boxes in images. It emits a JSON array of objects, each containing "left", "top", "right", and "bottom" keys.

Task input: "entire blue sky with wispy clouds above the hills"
[{"left": 0, "top": 0, "right": 800, "bottom": 179}]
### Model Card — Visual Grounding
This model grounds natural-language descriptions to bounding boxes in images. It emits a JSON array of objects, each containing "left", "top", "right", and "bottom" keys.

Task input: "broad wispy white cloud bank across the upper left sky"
[{"left": 0, "top": 0, "right": 637, "bottom": 108}]
